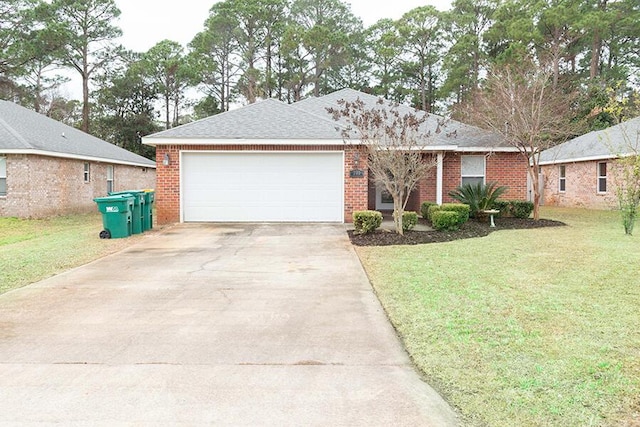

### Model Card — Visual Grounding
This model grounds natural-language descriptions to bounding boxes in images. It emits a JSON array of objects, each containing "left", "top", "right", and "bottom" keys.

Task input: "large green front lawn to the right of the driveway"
[{"left": 357, "top": 208, "right": 640, "bottom": 426}]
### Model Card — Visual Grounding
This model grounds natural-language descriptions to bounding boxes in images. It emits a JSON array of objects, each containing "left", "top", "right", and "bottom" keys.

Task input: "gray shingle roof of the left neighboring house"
[{"left": 0, "top": 100, "right": 156, "bottom": 167}]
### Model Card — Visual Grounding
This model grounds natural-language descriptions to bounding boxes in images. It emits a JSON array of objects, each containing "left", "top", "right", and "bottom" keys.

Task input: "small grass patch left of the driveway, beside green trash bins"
[{"left": 0, "top": 213, "right": 143, "bottom": 293}]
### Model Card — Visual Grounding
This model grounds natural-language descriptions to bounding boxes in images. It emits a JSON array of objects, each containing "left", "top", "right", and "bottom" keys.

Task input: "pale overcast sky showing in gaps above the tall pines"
[{"left": 116, "top": 0, "right": 451, "bottom": 52}]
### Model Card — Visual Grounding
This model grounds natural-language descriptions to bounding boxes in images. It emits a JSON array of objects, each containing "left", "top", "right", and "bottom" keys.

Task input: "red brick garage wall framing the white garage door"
[{"left": 155, "top": 145, "right": 368, "bottom": 224}]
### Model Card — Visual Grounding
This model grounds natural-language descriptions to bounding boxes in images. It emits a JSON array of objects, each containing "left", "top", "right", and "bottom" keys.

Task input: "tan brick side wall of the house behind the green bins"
[{"left": 0, "top": 154, "right": 156, "bottom": 218}]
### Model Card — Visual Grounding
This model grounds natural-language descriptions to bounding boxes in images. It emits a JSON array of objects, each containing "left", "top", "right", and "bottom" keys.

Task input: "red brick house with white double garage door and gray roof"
[{"left": 143, "top": 89, "right": 527, "bottom": 223}]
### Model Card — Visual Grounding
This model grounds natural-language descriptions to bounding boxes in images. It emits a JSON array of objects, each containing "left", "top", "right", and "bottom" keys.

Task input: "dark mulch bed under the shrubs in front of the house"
[{"left": 348, "top": 218, "right": 566, "bottom": 246}]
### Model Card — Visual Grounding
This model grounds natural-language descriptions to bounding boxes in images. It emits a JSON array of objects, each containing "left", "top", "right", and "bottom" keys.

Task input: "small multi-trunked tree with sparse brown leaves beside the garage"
[{"left": 327, "top": 98, "right": 441, "bottom": 234}]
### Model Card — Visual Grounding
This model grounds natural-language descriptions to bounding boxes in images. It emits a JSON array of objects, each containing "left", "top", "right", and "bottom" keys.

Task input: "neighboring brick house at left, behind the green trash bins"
[{"left": 0, "top": 101, "right": 156, "bottom": 218}]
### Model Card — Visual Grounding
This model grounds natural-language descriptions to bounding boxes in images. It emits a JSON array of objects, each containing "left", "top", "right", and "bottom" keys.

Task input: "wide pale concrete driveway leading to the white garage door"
[{"left": 0, "top": 224, "right": 456, "bottom": 426}]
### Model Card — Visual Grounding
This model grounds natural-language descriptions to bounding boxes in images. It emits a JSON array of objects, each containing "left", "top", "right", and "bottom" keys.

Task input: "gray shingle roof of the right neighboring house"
[{"left": 540, "top": 117, "right": 640, "bottom": 164}]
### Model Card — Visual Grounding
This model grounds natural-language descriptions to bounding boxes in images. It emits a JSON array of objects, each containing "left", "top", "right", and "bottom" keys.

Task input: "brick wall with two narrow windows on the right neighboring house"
[{"left": 542, "top": 161, "right": 618, "bottom": 209}]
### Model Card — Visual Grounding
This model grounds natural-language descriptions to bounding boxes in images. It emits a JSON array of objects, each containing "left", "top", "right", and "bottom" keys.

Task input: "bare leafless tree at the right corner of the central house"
[{"left": 460, "top": 62, "right": 577, "bottom": 220}]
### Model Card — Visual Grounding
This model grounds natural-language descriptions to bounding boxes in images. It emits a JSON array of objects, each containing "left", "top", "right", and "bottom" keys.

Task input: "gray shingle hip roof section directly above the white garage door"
[{"left": 145, "top": 99, "right": 342, "bottom": 141}]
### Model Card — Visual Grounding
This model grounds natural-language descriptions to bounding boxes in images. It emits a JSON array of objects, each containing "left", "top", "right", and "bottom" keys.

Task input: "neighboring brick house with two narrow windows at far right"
[{"left": 540, "top": 117, "right": 640, "bottom": 209}]
